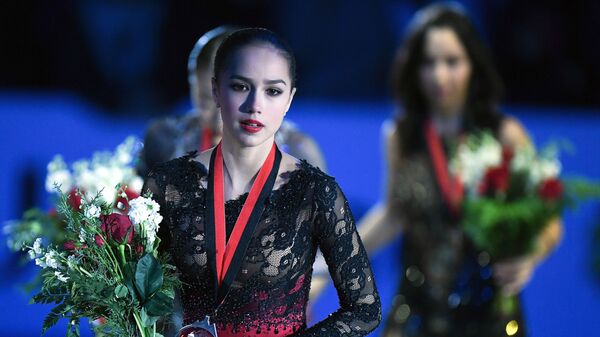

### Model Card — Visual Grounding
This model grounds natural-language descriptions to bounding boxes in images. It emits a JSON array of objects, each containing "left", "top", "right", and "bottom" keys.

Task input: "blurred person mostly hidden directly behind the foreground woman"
[{"left": 138, "top": 26, "right": 327, "bottom": 176}]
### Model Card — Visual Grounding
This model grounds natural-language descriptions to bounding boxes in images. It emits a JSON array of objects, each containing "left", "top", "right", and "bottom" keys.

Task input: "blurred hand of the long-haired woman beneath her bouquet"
[{"left": 493, "top": 255, "right": 538, "bottom": 296}]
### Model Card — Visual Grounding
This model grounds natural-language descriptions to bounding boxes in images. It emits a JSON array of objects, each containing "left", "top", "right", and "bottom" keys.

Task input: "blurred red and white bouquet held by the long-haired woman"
[{"left": 450, "top": 133, "right": 568, "bottom": 260}]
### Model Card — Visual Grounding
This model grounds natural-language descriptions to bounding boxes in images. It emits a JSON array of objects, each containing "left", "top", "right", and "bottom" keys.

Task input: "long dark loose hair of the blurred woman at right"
[{"left": 392, "top": 3, "right": 502, "bottom": 153}]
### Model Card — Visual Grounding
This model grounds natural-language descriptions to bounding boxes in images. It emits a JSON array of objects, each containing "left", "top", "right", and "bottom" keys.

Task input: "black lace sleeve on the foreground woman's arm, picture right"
[{"left": 298, "top": 177, "right": 381, "bottom": 336}]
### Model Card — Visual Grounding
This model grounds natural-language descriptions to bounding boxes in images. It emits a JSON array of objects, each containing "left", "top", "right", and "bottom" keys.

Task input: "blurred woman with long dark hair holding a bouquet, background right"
[{"left": 359, "top": 3, "right": 562, "bottom": 337}]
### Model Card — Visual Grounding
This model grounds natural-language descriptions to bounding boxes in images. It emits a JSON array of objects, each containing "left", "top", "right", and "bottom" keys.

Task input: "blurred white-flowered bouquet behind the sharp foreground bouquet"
[{"left": 3, "top": 137, "right": 143, "bottom": 258}]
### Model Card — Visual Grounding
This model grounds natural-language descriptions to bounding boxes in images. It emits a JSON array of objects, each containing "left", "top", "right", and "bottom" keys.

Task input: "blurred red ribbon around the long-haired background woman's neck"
[{"left": 424, "top": 120, "right": 464, "bottom": 216}]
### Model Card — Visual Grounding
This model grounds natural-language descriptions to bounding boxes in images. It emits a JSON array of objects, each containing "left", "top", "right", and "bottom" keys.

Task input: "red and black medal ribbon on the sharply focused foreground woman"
[{"left": 213, "top": 143, "right": 277, "bottom": 285}]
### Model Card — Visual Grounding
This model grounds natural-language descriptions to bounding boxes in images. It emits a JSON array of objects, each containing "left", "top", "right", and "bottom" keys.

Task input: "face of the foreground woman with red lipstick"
[{"left": 213, "top": 44, "right": 296, "bottom": 146}]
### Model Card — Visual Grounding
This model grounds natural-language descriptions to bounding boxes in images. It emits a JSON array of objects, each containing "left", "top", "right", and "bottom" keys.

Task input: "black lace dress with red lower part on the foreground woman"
[{"left": 145, "top": 156, "right": 381, "bottom": 337}]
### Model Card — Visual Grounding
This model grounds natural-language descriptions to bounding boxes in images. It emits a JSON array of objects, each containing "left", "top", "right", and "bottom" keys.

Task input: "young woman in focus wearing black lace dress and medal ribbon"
[{"left": 146, "top": 28, "right": 380, "bottom": 337}]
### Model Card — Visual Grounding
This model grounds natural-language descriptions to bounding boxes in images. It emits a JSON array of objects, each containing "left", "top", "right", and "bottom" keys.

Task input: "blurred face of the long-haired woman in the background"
[{"left": 419, "top": 27, "right": 472, "bottom": 116}]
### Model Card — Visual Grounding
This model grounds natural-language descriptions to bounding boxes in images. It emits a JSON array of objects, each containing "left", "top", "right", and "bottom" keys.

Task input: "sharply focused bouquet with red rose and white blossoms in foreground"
[{"left": 27, "top": 185, "right": 178, "bottom": 337}]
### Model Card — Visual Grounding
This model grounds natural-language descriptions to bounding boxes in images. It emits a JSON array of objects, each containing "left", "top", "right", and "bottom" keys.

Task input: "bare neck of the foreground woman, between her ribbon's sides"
[{"left": 221, "top": 137, "right": 273, "bottom": 200}]
